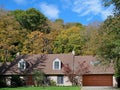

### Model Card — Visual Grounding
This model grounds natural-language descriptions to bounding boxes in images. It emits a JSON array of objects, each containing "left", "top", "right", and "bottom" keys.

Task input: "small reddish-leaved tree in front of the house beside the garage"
[{"left": 63, "top": 61, "right": 89, "bottom": 86}]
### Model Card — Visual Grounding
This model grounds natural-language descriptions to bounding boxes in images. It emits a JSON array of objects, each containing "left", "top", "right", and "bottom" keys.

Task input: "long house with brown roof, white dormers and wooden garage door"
[{"left": 1, "top": 54, "right": 116, "bottom": 86}]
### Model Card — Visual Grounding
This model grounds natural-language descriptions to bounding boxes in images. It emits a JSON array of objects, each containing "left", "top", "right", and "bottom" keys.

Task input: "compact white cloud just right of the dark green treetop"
[{"left": 40, "top": 3, "right": 60, "bottom": 19}]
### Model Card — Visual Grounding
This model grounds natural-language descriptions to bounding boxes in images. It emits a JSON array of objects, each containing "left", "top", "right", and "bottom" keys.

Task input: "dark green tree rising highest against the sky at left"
[{"left": 12, "top": 8, "right": 50, "bottom": 33}]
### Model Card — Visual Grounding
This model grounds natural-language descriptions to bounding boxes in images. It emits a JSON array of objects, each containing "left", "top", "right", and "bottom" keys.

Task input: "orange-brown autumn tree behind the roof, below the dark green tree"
[{"left": 21, "top": 31, "right": 51, "bottom": 54}]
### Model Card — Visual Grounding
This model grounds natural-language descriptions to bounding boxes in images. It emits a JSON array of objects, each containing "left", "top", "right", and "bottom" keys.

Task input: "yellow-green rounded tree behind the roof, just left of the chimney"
[{"left": 54, "top": 27, "right": 84, "bottom": 55}]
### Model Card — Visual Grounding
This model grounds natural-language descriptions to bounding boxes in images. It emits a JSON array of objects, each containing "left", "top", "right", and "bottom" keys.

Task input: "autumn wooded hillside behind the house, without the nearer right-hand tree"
[{"left": 0, "top": 8, "right": 101, "bottom": 62}]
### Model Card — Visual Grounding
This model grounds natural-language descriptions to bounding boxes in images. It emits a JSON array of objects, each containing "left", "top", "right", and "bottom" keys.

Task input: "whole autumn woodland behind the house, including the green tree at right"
[{"left": 0, "top": 0, "right": 120, "bottom": 77}]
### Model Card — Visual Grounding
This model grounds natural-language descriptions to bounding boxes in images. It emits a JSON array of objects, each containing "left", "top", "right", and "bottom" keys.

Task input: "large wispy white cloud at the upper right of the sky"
[{"left": 72, "top": 0, "right": 113, "bottom": 20}]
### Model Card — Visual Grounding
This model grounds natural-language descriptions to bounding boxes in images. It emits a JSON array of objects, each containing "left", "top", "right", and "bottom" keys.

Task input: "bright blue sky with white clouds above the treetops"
[{"left": 0, "top": 0, "right": 113, "bottom": 25}]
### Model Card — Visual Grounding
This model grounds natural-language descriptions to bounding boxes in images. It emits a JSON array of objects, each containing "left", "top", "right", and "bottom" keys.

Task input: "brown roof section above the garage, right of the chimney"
[{"left": 75, "top": 56, "right": 114, "bottom": 74}]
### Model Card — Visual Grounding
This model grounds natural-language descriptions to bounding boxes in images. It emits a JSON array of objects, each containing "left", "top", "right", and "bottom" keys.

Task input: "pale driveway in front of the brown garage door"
[{"left": 81, "top": 86, "right": 120, "bottom": 90}]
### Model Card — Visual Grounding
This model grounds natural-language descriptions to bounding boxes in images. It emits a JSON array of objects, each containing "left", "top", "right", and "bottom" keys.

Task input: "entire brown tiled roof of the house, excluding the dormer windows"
[{"left": 0, "top": 54, "right": 114, "bottom": 75}]
